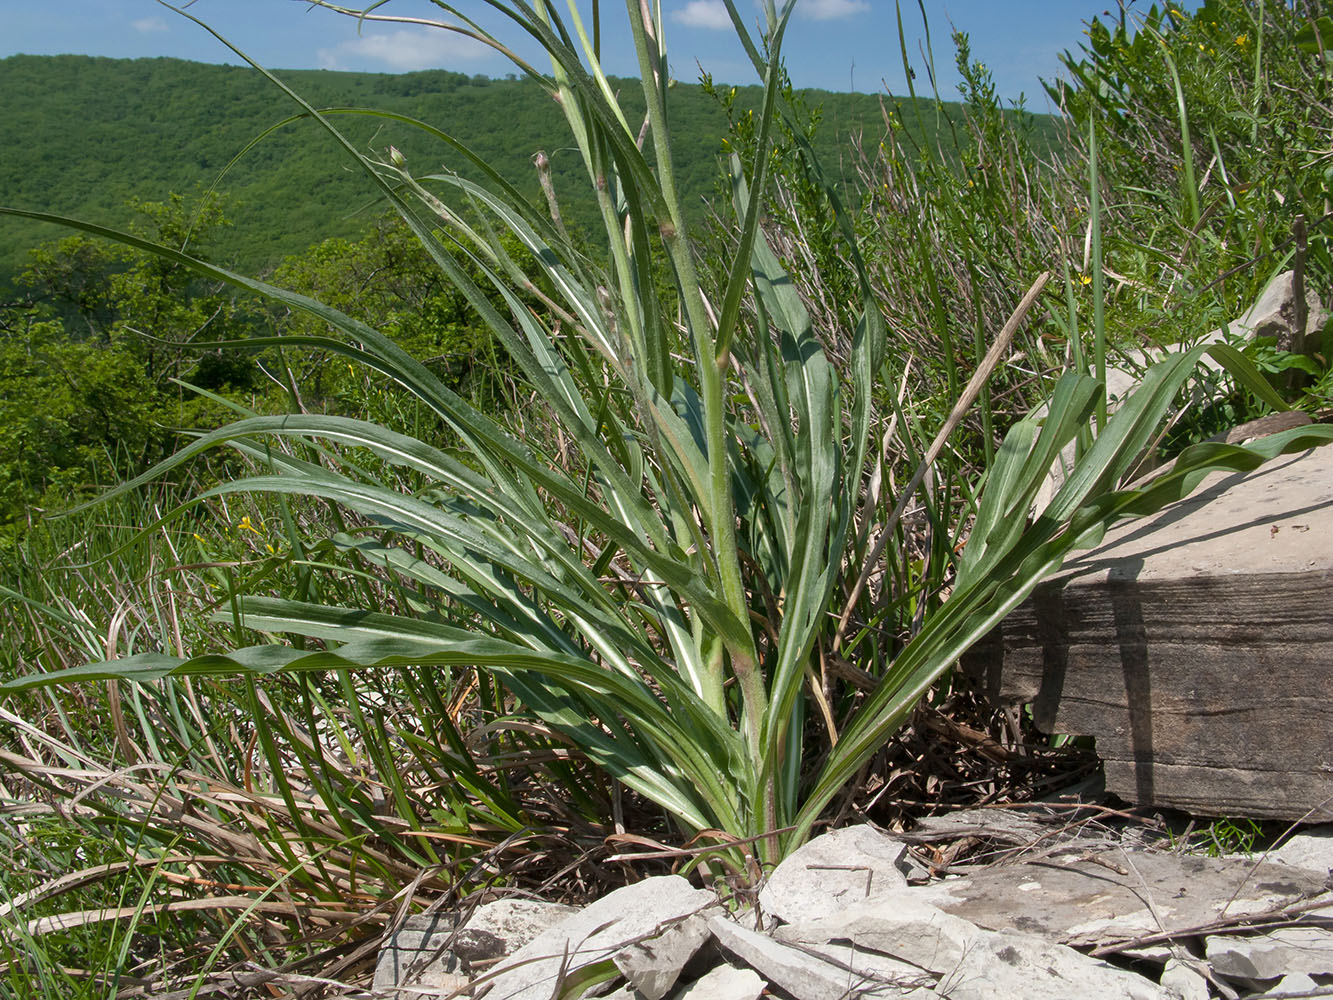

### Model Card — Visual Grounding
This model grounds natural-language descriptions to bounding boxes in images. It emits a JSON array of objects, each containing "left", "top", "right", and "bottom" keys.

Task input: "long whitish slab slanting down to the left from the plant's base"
[{"left": 485, "top": 875, "right": 716, "bottom": 1000}]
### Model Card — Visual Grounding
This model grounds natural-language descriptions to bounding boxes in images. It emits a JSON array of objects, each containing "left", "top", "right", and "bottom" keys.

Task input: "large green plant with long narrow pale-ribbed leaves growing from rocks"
[{"left": 5, "top": 0, "right": 1333, "bottom": 877}]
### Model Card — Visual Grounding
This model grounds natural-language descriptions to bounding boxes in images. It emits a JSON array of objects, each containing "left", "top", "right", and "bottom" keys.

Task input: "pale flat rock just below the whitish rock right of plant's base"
[{"left": 773, "top": 892, "right": 981, "bottom": 973}]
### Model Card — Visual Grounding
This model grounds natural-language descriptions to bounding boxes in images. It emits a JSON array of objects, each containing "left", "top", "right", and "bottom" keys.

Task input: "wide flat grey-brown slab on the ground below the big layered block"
[{"left": 906, "top": 849, "right": 1322, "bottom": 961}]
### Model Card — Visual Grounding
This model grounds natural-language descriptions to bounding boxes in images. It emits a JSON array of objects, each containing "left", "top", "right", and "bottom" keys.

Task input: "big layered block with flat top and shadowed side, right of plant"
[{"left": 968, "top": 448, "right": 1333, "bottom": 819}]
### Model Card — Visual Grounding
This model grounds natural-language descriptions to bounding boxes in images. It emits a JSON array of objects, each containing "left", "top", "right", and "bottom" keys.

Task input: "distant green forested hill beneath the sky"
[{"left": 0, "top": 56, "right": 1034, "bottom": 287}]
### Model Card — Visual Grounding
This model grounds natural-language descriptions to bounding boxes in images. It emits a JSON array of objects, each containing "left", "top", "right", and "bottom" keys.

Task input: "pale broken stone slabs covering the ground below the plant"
[{"left": 375, "top": 808, "right": 1333, "bottom": 1000}]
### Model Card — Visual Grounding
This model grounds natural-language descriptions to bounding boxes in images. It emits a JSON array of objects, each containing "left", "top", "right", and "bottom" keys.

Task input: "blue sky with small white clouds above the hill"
[{"left": 0, "top": 0, "right": 1197, "bottom": 111}]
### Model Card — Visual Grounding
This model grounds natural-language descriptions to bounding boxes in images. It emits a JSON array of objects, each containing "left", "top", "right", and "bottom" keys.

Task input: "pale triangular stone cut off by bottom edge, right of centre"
[{"left": 936, "top": 932, "right": 1176, "bottom": 1000}]
